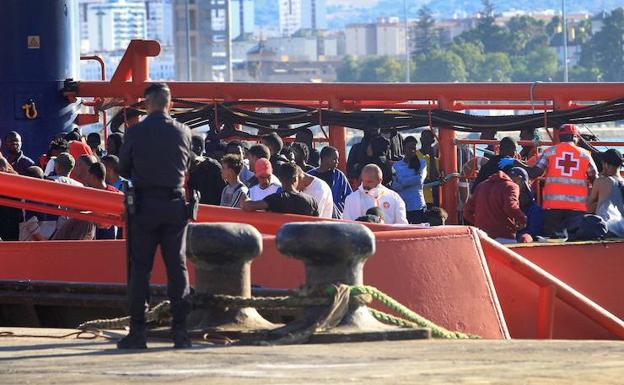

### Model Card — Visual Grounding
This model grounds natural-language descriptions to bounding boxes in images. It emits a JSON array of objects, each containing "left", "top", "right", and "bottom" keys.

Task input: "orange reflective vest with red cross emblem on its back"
[{"left": 542, "top": 142, "right": 591, "bottom": 211}]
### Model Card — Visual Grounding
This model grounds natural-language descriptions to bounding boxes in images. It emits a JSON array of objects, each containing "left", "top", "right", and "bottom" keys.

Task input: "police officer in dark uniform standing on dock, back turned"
[{"left": 117, "top": 83, "right": 192, "bottom": 349}]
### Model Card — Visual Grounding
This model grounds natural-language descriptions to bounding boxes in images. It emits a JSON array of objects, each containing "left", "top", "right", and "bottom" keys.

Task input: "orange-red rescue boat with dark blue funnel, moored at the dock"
[{"left": 0, "top": 0, "right": 624, "bottom": 339}]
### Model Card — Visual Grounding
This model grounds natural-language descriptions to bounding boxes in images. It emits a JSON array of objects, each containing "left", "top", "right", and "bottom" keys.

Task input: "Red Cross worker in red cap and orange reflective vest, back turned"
[{"left": 528, "top": 124, "right": 597, "bottom": 238}]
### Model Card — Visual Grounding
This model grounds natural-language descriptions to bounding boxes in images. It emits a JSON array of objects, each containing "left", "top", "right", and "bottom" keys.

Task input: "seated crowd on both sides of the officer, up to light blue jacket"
[{"left": 0, "top": 129, "right": 447, "bottom": 240}]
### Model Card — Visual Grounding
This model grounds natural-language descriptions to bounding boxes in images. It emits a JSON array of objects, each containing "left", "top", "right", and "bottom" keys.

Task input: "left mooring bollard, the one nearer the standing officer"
[{"left": 186, "top": 223, "right": 275, "bottom": 331}]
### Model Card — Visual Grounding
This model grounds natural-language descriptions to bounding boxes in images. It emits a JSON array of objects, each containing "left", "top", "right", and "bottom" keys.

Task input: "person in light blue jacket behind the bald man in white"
[{"left": 392, "top": 136, "right": 429, "bottom": 224}]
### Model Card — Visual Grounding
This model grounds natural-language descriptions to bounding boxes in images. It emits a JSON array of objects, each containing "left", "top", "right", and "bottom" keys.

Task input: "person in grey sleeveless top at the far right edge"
[{"left": 587, "top": 148, "right": 624, "bottom": 237}]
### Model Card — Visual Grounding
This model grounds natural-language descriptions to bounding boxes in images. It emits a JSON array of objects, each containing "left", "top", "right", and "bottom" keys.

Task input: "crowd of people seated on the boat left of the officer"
[{"left": 0, "top": 129, "right": 125, "bottom": 241}]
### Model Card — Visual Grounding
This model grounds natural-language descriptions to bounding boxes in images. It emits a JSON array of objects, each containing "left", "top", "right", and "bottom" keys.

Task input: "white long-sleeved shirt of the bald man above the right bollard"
[{"left": 343, "top": 185, "right": 408, "bottom": 224}]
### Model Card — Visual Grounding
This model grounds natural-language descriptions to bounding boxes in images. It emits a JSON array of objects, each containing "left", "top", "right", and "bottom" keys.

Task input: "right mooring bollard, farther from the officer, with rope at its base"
[{"left": 276, "top": 222, "right": 391, "bottom": 331}]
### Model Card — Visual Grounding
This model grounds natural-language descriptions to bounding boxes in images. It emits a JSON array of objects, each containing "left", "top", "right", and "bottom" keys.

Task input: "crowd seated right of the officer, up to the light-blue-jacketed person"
[{"left": 189, "top": 129, "right": 446, "bottom": 224}]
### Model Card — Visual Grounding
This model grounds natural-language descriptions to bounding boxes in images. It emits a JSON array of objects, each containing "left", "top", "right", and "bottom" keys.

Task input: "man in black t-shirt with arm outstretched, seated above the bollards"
[{"left": 242, "top": 159, "right": 319, "bottom": 217}]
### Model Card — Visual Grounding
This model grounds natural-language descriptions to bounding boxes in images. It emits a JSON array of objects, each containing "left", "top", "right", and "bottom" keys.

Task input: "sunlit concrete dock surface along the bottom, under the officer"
[{"left": 0, "top": 328, "right": 624, "bottom": 385}]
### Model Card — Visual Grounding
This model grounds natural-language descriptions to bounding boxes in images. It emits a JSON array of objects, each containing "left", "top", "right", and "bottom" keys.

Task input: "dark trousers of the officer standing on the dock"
[{"left": 128, "top": 197, "right": 191, "bottom": 328}]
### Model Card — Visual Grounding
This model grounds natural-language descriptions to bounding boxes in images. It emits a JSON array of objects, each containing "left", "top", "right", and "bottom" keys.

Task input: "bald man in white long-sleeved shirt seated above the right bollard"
[{"left": 343, "top": 164, "right": 408, "bottom": 224}]
